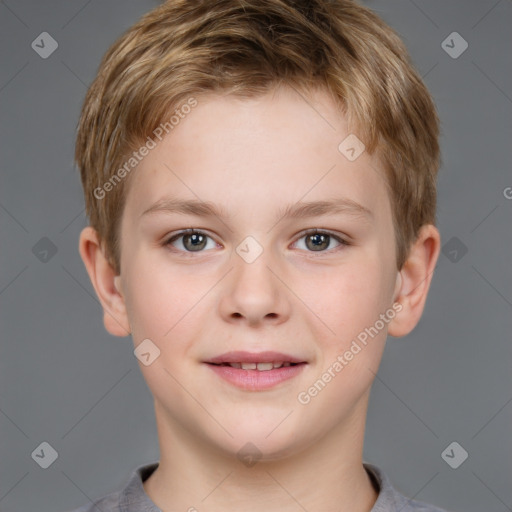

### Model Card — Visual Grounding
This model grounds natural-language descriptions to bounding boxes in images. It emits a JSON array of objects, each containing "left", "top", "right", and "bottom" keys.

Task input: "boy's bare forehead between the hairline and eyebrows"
[{"left": 122, "top": 87, "right": 389, "bottom": 224}]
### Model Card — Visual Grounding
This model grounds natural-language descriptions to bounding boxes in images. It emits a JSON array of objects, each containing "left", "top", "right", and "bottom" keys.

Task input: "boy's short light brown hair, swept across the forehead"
[{"left": 75, "top": 0, "right": 440, "bottom": 272}]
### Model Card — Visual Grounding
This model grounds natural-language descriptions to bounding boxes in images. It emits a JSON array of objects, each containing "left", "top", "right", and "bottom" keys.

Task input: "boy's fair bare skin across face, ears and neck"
[{"left": 80, "top": 87, "right": 440, "bottom": 512}]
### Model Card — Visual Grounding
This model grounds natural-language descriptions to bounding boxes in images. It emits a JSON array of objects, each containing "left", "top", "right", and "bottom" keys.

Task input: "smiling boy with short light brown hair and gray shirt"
[{"left": 71, "top": 0, "right": 448, "bottom": 512}]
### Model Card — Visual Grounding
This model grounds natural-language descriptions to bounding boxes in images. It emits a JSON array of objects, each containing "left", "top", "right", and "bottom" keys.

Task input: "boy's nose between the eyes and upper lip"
[{"left": 219, "top": 245, "right": 291, "bottom": 327}]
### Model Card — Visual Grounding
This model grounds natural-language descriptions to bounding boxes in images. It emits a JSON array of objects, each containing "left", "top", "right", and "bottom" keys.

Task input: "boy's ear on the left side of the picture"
[{"left": 79, "top": 226, "right": 131, "bottom": 336}]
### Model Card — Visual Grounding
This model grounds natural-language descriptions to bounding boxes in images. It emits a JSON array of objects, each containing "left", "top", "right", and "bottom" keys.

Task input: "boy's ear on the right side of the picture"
[{"left": 388, "top": 224, "right": 441, "bottom": 338}]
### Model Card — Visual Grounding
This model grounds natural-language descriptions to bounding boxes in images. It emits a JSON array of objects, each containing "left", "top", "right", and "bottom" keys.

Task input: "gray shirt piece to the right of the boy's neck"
[{"left": 364, "top": 463, "right": 449, "bottom": 512}]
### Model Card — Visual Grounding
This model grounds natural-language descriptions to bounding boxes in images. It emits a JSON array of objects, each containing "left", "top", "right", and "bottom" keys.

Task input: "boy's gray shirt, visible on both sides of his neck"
[{"left": 68, "top": 462, "right": 447, "bottom": 512}]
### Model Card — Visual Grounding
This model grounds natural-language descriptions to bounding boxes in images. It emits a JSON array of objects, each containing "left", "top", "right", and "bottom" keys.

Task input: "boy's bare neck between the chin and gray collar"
[{"left": 143, "top": 392, "right": 378, "bottom": 512}]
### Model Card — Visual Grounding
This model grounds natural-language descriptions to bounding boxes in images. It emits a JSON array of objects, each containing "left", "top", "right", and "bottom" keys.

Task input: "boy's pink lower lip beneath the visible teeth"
[{"left": 207, "top": 363, "right": 306, "bottom": 391}]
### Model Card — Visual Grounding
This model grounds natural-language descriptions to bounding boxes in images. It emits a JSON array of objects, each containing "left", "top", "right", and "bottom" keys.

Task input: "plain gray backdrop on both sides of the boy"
[{"left": 0, "top": 0, "right": 512, "bottom": 512}]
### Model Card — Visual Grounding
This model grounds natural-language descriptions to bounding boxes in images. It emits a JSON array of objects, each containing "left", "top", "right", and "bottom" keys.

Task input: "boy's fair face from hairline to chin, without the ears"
[{"left": 116, "top": 85, "right": 398, "bottom": 458}]
